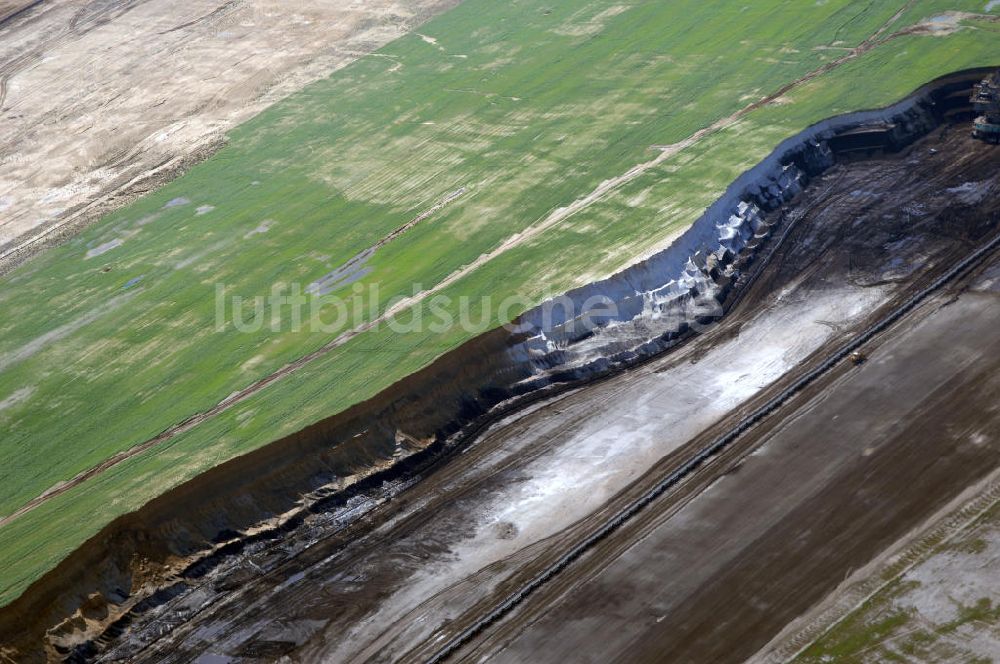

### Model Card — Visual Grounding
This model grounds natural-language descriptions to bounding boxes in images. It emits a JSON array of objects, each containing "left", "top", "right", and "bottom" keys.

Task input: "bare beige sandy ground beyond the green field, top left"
[{"left": 0, "top": 0, "right": 459, "bottom": 268}]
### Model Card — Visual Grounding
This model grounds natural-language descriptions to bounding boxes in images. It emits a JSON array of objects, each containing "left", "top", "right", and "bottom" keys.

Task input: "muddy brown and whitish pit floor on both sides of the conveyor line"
[{"left": 70, "top": 127, "right": 1000, "bottom": 662}]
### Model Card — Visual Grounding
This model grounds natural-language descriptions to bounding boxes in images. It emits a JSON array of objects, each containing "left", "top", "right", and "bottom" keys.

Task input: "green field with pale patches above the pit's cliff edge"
[{"left": 0, "top": 0, "right": 1000, "bottom": 603}]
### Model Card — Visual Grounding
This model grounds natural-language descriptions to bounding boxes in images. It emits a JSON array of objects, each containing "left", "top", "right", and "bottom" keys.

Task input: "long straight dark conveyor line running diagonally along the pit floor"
[{"left": 424, "top": 227, "right": 1000, "bottom": 664}]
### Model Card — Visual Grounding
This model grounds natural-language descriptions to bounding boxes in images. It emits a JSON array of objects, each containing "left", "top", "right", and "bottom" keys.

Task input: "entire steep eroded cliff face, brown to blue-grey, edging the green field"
[{"left": 0, "top": 71, "right": 981, "bottom": 662}]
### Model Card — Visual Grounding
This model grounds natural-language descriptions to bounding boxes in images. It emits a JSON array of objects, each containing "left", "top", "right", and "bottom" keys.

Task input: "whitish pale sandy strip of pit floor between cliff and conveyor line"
[{"left": 99, "top": 274, "right": 887, "bottom": 661}]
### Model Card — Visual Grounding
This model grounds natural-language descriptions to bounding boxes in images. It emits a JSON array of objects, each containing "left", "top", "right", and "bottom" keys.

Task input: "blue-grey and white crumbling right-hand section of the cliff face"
[{"left": 512, "top": 87, "right": 944, "bottom": 387}]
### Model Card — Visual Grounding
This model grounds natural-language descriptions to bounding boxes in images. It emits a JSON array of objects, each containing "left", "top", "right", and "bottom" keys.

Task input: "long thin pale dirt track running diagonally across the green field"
[{"left": 0, "top": 0, "right": 928, "bottom": 528}]
